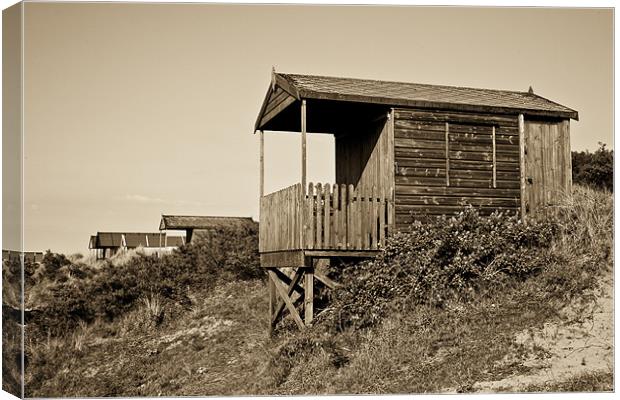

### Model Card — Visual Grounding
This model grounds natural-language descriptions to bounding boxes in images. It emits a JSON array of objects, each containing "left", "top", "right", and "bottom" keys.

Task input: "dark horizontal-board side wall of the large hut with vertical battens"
[{"left": 394, "top": 109, "right": 521, "bottom": 229}]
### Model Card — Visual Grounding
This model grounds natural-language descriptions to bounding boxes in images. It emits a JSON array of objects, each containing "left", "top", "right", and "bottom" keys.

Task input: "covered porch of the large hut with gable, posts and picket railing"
[{"left": 255, "top": 74, "right": 394, "bottom": 268}]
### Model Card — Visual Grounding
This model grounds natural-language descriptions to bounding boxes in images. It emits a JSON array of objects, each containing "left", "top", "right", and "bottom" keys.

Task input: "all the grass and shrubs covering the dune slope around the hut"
[{"left": 26, "top": 185, "right": 613, "bottom": 396}]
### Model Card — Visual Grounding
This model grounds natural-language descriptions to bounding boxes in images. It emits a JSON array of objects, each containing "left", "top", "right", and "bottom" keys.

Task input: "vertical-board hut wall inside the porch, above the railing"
[{"left": 336, "top": 116, "right": 394, "bottom": 196}]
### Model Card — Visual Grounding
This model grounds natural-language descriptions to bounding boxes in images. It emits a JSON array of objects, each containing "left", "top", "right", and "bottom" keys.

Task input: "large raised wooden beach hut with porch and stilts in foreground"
[{"left": 254, "top": 71, "right": 578, "bottom": 327}]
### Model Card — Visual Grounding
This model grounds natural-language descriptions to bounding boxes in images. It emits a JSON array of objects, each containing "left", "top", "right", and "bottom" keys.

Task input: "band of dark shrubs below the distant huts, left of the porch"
[{"left": 27, "top": 225, "right": 262, "bottom": 336}]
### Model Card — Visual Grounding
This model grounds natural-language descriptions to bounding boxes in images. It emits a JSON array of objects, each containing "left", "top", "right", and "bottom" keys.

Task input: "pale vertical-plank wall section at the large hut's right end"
[{"left": 524, "top": 117, "right": 572, "bottom": 215}]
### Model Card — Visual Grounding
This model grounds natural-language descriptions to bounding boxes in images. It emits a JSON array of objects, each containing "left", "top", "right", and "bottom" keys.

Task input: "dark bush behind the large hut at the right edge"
[{"left": 572, "top": 142, "right": 614, "bottom": 191}]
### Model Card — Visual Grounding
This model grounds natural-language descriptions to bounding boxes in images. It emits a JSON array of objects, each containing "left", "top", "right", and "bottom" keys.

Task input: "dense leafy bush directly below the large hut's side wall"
[{"left": 326, "top": 208, "right": 557, "bottom": 329}]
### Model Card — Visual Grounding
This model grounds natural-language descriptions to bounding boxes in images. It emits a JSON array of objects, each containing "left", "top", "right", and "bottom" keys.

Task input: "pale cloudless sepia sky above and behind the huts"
[{"left": 14, "top": 3, "right": 613, "bottom": 252}]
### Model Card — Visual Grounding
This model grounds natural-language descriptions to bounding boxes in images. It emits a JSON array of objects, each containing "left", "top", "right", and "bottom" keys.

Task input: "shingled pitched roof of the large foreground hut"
[{"left": 256, "top": 72, "right": 579, "bottom": 129}]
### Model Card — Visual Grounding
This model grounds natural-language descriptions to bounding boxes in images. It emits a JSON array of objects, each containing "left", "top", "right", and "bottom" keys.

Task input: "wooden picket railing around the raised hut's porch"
[{"left": 259, "top": 183, "right": 393, "bottom": 252}]
